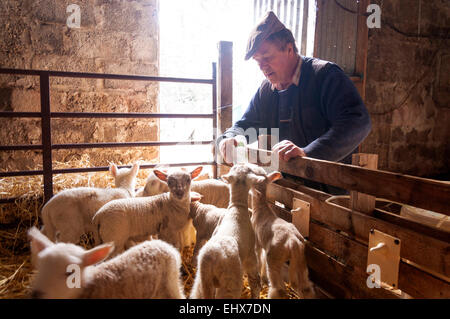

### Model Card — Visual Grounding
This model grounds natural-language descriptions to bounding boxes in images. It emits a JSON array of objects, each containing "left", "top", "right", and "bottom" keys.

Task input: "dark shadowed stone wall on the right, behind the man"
[{"left": 362, "top": 0, "right": 450, "bottom": 176}]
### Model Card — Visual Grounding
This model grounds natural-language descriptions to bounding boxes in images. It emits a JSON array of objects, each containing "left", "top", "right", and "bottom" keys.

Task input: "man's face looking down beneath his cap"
[{"left": 253, "top": 41, "right": 296, "bottom": 87}]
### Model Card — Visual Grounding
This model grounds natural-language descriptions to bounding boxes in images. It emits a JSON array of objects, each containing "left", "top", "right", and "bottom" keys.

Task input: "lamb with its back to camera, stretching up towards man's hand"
[{"left": 192, "top": 164, "right": 261, "bottom": 298}]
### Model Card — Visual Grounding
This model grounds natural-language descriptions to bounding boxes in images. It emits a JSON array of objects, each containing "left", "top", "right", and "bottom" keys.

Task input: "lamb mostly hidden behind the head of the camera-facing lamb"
[{"left": 136, "top": 169, "right": 230, "bottom": 208}]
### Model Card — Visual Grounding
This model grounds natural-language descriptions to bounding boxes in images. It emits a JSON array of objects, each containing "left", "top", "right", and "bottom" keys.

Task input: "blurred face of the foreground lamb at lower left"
[{"left": 31, "top": 243, "right": 84, "bottom": 299}]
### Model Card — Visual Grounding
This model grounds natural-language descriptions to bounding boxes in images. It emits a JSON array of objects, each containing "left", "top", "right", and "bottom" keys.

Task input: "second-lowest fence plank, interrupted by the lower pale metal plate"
[{"left": 309, "top": 222, "right": 450, "bottom": 298}]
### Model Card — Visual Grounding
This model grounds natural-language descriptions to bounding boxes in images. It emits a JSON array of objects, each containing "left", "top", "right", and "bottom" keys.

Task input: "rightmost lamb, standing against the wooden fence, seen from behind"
[{"left": 246, "top": 165, "right": 315, "bottom": 298}]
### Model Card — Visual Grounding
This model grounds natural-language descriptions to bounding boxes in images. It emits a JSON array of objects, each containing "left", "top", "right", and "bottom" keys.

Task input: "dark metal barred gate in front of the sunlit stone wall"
[{"left": 0, "top": 63, "right": 217, "bottom": 203}]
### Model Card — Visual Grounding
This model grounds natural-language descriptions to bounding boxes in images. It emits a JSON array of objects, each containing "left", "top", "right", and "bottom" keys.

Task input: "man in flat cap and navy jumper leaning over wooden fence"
[{"left": 217, "top": 12, "right": 371, "bottom": 191}]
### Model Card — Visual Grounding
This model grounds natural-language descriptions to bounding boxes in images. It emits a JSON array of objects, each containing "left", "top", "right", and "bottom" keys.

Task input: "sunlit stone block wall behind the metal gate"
[{"left": 0, "top": 0, "right": 159, "bottom": 170}]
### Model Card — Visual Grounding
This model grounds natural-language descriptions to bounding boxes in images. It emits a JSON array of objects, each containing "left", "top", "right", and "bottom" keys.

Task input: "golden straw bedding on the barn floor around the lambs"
[{"left": 0, "top": 155, "right": 299, "bottom": 299}]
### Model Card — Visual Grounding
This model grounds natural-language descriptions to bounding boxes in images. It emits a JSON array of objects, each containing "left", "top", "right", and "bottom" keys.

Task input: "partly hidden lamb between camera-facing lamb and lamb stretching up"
[{"left": 189, "top": 201, "right": 228, "bottom": 267}]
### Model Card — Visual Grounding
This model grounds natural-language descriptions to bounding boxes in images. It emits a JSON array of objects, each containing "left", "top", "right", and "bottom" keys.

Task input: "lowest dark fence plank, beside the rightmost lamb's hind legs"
[{"left": 305, "top": 242, "right": 400, "bottom": 299}]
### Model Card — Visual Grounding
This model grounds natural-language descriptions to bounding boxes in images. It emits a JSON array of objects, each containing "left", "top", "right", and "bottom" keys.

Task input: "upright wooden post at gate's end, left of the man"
[{"left": 217, "top": 41, "right": 233, "bottom": 176}]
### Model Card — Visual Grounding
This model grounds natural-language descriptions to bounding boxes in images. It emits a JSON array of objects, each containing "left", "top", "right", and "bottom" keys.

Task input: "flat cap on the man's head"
[{"left": 245, "top": 11, "right": 286, "bottom": 60}]
